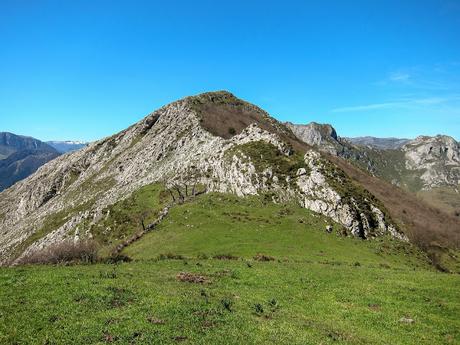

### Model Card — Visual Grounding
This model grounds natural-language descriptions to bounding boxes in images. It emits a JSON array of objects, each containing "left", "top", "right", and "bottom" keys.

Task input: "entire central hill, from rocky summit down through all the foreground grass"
[{"left": 0, "top": 92, "right": 460, "bottom": 345}]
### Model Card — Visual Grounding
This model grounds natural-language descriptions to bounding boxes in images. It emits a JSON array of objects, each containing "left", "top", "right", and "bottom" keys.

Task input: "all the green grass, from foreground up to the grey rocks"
[{"left": 0, "top": 194, "right": 460, "bottom": 344}]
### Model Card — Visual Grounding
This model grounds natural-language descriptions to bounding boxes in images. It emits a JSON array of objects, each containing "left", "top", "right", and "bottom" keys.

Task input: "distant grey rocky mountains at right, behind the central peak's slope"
[{"left": 287, "top": 123, "right": 460, "bottom": 192}]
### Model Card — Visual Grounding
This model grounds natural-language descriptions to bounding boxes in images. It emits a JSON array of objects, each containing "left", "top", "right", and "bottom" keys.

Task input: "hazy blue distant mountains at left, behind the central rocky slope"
[{"left": 0, "top": 132, "right": 87, "bottom": 191}]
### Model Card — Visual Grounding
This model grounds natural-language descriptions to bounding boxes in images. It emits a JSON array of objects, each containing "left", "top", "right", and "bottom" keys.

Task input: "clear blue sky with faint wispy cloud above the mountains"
[{"left": 0, "top": 0, "right": 460, "bottom": 140}]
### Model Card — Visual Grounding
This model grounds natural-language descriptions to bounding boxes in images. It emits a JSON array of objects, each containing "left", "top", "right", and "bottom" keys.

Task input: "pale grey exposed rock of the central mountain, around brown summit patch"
[{"left": 0, "top": 92, "right": 405, "bottom": 263}]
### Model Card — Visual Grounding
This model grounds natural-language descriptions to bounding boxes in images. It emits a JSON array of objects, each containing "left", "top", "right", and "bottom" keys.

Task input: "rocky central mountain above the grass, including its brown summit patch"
[{"left": 0, "top": 91, "right": 455, "bottom": 272}]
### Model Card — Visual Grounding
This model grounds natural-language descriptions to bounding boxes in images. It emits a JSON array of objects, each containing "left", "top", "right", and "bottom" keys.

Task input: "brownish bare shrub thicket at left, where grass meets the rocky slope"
[{"left": 19, "top": 240, "right": 98, "bottom": 265}]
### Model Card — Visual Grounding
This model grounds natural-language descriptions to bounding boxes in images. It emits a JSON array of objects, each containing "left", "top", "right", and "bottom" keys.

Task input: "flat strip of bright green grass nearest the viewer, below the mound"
[{"left": 0, "top": 260, "right": 460, "bottom": 344}]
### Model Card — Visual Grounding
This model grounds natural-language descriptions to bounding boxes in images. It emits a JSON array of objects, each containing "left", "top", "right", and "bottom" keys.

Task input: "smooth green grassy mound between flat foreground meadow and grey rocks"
[{"left": 124, "top": 194, "right": 428, "bottom": 267}]
